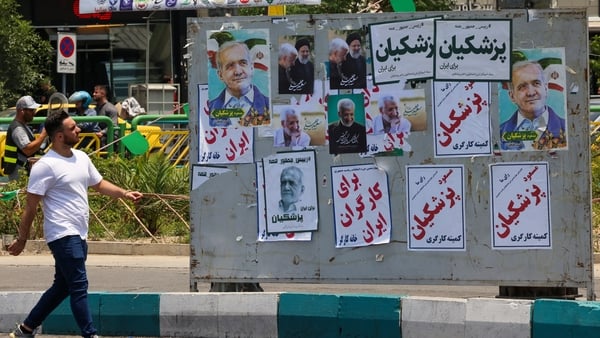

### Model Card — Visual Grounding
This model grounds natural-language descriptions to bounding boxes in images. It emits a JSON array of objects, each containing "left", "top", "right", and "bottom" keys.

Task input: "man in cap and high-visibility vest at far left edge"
[{"left": 2, "top": 96, "right": 47, "bottom": 181}]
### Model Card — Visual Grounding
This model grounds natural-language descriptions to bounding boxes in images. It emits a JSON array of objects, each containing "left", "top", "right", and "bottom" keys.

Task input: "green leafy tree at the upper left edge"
[{"left": 0, "top": 0, "right": 53, "bottom": 109}]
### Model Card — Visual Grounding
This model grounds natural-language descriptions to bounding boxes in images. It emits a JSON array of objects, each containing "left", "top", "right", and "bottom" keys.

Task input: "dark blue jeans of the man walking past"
[{"left": 23, "top": 236, "right": 96, "bottom": 337}]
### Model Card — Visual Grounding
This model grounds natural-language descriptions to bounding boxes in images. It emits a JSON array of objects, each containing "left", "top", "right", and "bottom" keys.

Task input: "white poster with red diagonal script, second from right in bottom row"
[{"left": 406, "top": 165, "right": 466, "bottom": 251}]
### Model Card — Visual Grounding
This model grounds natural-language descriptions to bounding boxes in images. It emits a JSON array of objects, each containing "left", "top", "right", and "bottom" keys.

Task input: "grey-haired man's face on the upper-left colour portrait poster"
[{"left": 217, "top": 45, "right": 254, "bottom": 98}]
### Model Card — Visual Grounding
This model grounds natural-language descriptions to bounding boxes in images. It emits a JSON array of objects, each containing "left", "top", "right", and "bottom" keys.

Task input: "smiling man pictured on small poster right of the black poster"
[{"left": 373, "top": 94, "right": 411, "bottom": 135}]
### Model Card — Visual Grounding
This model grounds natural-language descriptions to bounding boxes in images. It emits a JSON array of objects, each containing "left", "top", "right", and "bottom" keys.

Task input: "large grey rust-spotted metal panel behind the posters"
[{"left": 188, "top": 10, "right": 593, "bottom": 296}]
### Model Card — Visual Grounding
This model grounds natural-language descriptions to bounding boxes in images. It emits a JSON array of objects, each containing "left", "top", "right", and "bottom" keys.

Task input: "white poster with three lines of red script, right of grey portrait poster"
[{"left": 331, "top": 164, "right": 392, "bottom": 248}]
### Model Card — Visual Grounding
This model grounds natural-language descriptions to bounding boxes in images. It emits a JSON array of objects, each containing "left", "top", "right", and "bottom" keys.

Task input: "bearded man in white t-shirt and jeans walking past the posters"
[{"left": 8, "top": 111, "right": 143, "bottom": 338}]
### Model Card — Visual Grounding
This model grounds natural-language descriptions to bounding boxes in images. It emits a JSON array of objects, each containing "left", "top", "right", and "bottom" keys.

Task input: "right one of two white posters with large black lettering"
[{"left": 435, "top": 19, "right": 512, "bottom": 81}]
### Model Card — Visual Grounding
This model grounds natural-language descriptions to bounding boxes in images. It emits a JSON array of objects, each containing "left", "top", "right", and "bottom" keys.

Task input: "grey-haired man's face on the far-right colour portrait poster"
[{"left": 509, "top": 64, "right": 548, "bottom": 119}]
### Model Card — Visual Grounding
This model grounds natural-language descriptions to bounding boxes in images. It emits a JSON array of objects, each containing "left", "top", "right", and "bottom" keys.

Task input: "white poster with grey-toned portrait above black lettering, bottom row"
[{"left": 262, "top": 150, "right": 319, "bottom": 234}]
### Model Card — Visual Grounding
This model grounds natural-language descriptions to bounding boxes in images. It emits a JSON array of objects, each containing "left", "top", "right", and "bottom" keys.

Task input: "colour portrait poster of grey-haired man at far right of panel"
[{"left": 498, "top": 47, "right": 568, "bottom": 151}]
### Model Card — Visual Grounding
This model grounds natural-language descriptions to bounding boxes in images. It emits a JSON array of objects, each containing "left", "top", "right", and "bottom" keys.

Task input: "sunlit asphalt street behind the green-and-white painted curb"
[{"left": 0, "top": 251, "right": 600, "bottom": 298}]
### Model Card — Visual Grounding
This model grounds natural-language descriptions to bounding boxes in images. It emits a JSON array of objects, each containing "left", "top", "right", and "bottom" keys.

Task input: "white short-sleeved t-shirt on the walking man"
[{"left": 27, "top": 149, "right": 102, "bottom": 243}]
